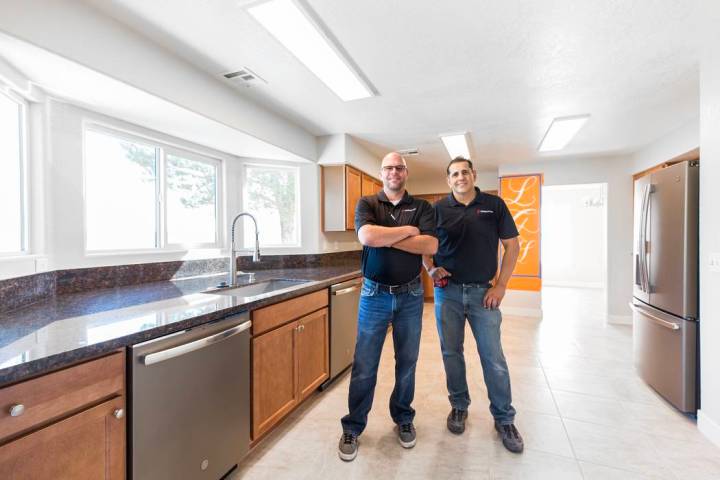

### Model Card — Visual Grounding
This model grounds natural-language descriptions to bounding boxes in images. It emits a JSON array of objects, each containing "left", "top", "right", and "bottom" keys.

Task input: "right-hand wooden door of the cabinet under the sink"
[{"left": 297, "top": 308, "right": 330, "bottom": 401}]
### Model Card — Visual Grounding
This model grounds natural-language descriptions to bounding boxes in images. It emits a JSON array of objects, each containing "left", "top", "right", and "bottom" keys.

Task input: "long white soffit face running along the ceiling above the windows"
[{"left": 0, "top": 0, "right": 317, "bottom": 161}]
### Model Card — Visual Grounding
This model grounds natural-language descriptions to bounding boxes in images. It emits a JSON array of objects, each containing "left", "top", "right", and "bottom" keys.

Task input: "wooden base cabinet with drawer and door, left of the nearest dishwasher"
[{"left": 0, "top": 352, "right": 126, "bottom": 480}]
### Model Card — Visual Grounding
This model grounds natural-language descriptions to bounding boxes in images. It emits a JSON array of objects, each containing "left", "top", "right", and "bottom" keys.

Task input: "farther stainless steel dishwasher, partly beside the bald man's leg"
[{"left": 321, "top": 277, "right": 362, "bottom": 389}]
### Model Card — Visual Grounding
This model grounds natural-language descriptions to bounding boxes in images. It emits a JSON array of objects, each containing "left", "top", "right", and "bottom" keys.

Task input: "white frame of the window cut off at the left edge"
[{"left": 0, "top": 87, "right": 30, "bottom": 258}]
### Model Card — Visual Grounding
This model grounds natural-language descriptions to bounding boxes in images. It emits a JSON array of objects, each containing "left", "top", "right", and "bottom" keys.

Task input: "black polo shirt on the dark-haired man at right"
[{"left": 434, "top": 187, "right": 518, "bottom": 283}]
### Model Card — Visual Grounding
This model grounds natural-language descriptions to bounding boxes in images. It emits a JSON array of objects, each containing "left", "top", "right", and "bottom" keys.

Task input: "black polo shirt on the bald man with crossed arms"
[{"left": 355, "top": 190, "right": 435, "bottom": 285}]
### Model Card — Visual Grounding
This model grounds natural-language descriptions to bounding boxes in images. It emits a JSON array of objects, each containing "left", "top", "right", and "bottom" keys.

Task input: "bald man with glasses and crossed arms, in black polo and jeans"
[{"left": 338, "top": 152, "right": 438, "bottom": 461}]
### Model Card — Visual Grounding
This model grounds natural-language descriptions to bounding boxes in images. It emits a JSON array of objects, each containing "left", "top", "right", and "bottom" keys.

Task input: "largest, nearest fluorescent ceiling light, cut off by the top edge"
[{"left": 248, "top": 0, "right": 373, "bottom": 102}]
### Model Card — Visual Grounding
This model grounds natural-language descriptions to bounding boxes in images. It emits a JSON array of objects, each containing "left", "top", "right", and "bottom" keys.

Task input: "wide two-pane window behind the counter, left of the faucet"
[{"left": 85, "top": 127, "right": 220, "bottom": 253}]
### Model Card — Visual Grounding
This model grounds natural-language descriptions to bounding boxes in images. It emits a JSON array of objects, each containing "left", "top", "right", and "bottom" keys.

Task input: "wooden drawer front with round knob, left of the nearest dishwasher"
[{"left": 0, "top": 352, "right": 125, "bottom": 442}]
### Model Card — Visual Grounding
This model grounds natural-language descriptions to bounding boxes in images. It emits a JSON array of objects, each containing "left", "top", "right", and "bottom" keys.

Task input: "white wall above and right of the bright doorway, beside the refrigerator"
[{"left": 499, "top": 156, "right": 633, "bottom": 323}]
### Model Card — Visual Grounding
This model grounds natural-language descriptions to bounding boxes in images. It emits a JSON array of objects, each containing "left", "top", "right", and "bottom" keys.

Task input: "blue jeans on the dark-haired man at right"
[{"left": 435, "top": 281, "right": 515, "bottom": 425}]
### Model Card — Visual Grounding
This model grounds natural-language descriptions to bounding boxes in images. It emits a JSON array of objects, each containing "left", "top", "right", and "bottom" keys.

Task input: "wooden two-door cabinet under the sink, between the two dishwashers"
[{"left": 252, "top": 290, "right": 330, "bottom": 441}]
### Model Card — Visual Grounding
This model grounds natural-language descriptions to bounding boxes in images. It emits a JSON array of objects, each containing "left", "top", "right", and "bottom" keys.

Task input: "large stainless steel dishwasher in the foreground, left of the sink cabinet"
[{"left": 128, "top": 312, "right": 250, "bottom": 480}]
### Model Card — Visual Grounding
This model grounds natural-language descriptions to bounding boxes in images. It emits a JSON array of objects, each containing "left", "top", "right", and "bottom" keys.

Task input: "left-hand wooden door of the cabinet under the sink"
[{"left": 252, "top": 321, "right": 298, "bottom": 440}]
